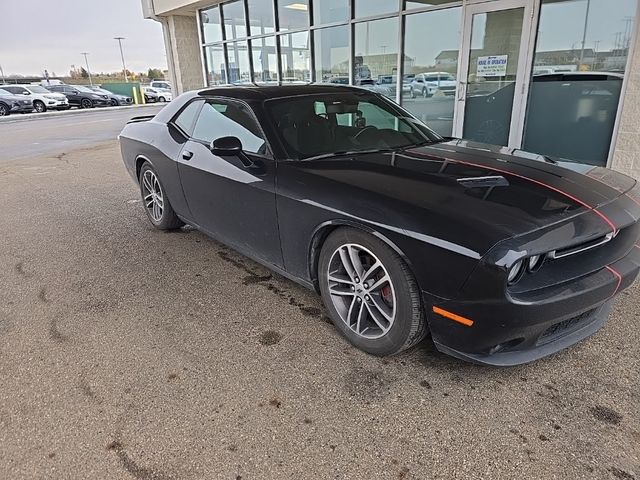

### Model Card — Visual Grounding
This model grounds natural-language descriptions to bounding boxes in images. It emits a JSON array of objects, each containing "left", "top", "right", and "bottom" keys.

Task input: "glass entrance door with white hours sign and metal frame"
[{"left": 454, "top": 0, "right": 534, "bottom": 148}]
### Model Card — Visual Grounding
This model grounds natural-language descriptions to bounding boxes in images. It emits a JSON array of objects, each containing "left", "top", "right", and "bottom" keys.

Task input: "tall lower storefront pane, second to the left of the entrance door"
[{"left": 353, "top": 17, "right": 398, "bottom": 98}]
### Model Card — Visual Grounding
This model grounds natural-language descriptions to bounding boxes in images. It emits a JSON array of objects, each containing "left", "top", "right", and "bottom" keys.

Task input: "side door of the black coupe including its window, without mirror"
[{"left": 177, "top": 98, "right": 282, "bottom": 266}]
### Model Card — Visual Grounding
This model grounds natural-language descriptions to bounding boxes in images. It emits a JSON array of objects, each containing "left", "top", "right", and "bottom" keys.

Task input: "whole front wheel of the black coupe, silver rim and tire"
[{"left": 318, "top": 228, "right": 427, "bottom": 355}]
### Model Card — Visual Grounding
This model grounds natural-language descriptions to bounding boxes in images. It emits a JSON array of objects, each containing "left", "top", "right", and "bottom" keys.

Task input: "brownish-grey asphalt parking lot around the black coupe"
[{"left": 0, "top": 112, "right": 640, "bottom": 480}]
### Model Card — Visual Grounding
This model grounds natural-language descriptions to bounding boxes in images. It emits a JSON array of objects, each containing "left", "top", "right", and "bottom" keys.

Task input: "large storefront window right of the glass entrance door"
[{"left": 523, "top": 0, "right": 636, "bottom": 165}]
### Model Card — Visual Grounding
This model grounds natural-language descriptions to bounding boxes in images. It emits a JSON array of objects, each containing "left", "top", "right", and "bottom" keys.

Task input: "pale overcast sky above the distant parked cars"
[{"left": 0, "top": 0, "right": 167, "bottom": 75}]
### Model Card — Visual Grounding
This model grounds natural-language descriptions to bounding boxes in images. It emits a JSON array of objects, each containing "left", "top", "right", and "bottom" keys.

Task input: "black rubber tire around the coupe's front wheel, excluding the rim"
[{"left": 318, "top": 227, "right": 428, "bottom": 356}]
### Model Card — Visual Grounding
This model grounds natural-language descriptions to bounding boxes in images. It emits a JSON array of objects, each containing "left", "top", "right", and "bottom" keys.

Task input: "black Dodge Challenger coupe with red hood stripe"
[{"left": 120, "top": 85, "right": 640, "bottom": 366}]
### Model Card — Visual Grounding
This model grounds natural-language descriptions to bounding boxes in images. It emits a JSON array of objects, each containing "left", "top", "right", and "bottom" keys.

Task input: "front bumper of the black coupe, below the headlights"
[{"left": 425, "top": 246, "right": 640, "bottom": 366}]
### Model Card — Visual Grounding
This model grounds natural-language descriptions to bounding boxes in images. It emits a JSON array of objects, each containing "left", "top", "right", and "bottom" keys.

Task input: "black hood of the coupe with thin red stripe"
[{"left": 290, "top": 140, "right": 636, "bottom": 252}]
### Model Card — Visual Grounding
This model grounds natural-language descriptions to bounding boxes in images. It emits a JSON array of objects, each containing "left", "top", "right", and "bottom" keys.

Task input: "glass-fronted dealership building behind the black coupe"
[{"left": 142, "top": 0, "right": 640, "bottom": 179}]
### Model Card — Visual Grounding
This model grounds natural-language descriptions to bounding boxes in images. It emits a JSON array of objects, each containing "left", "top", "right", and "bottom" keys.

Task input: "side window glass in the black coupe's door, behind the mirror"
[{"left": 193, "top": 100, "right": 266, "bottom": 154}]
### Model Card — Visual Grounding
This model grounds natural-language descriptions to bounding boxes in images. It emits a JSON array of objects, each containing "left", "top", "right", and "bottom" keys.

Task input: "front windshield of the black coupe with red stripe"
[{"left": 265, "top": 91, "right": 442, "bottom": 160}]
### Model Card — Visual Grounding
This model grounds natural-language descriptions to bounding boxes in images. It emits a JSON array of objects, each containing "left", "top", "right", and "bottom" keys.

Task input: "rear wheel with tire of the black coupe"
[{"left": 140, "top": 162, "right": 184, "bottom": 230}]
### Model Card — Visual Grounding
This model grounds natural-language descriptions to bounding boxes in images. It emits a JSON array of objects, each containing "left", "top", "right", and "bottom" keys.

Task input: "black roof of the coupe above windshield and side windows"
[{"left": 196, "top": 83, "right": 370, "bottom": 100}]
